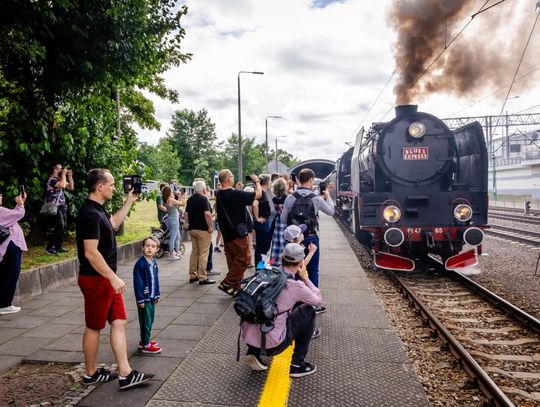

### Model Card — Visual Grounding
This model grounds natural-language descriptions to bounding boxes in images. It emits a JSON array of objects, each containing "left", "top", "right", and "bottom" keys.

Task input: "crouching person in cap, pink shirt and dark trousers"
[{"left": 242, "top": 243, "right": 322, "bottom": 377}]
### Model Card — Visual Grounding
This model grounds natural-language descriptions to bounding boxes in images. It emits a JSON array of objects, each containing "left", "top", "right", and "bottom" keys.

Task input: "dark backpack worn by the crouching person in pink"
[{"left": 233, "top": 267, "right": 293, "bottom": 361}]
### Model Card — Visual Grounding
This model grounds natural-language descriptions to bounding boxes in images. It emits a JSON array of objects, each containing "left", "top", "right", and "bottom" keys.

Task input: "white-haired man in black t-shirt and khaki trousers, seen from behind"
[{"left": 184, "top": 180, "right": 215, "bottom": 285}]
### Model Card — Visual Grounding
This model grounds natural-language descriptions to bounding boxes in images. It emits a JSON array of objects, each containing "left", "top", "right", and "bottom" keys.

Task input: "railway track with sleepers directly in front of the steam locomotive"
[{"left": 391, "top": 260, "right": 540, "bottom": 407}]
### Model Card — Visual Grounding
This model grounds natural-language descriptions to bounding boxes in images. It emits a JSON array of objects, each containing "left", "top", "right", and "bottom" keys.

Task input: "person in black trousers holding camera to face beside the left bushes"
[{"left": 45, "top": 164, "right": 75, "bottom": 256}]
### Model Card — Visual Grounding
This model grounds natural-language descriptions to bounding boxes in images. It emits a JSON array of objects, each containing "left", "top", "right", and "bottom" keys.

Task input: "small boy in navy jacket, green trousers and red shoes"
[{"left": 133, "top": 236, "right": 161, "bottom": 354}]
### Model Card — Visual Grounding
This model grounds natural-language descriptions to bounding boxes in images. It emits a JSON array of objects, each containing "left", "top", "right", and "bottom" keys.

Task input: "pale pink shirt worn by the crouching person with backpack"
[{"left": 242, "top": 269, "right": 322, "bottom": 349}]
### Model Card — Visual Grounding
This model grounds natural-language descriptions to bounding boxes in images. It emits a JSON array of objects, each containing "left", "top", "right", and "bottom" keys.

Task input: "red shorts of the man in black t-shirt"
[{"left": 79, "top": 275, "right": 127, "bottom": 331}]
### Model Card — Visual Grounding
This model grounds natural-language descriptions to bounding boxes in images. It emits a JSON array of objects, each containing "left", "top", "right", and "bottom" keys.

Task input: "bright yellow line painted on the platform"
[{"left": 259, "top": 344, "right": 294, "bottom": 407}]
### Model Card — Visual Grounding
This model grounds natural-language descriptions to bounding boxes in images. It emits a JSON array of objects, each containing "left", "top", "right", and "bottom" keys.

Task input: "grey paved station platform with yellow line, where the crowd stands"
[{"left": 0, "top": 214, "right": 430, "bottom": 407}]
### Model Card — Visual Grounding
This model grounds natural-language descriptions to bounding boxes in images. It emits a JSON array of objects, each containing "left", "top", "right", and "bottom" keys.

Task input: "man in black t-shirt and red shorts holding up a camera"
[{"left": 76, "top": 169, "right": 154, "bottom": 389}]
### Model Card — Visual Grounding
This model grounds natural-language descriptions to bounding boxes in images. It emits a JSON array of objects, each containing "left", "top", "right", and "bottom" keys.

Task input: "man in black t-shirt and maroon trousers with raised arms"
[{"left": 216, "top": 169, "right": 262, "bottom": 295}]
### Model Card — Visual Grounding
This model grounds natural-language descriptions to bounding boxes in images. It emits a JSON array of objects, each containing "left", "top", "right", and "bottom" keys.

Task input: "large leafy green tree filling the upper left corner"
[{"left": 0, "top": 0, "right": 190, "bottom": 233}]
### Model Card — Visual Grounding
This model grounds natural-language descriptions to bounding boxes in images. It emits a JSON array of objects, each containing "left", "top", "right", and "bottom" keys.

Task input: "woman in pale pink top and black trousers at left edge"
[{"left": 0, "top": 188, "right": 27, "bottom": 315}]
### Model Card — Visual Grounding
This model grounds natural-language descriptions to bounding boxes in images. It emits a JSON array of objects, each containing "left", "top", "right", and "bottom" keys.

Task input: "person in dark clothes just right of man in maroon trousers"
[{"left": 253, "top": 174, "right": 272, "bottom": 266}]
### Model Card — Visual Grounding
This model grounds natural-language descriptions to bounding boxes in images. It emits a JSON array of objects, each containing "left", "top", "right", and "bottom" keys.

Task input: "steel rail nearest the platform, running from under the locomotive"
[{"left": 390, "top": 272, "right": 515, "bottom": 407}]
